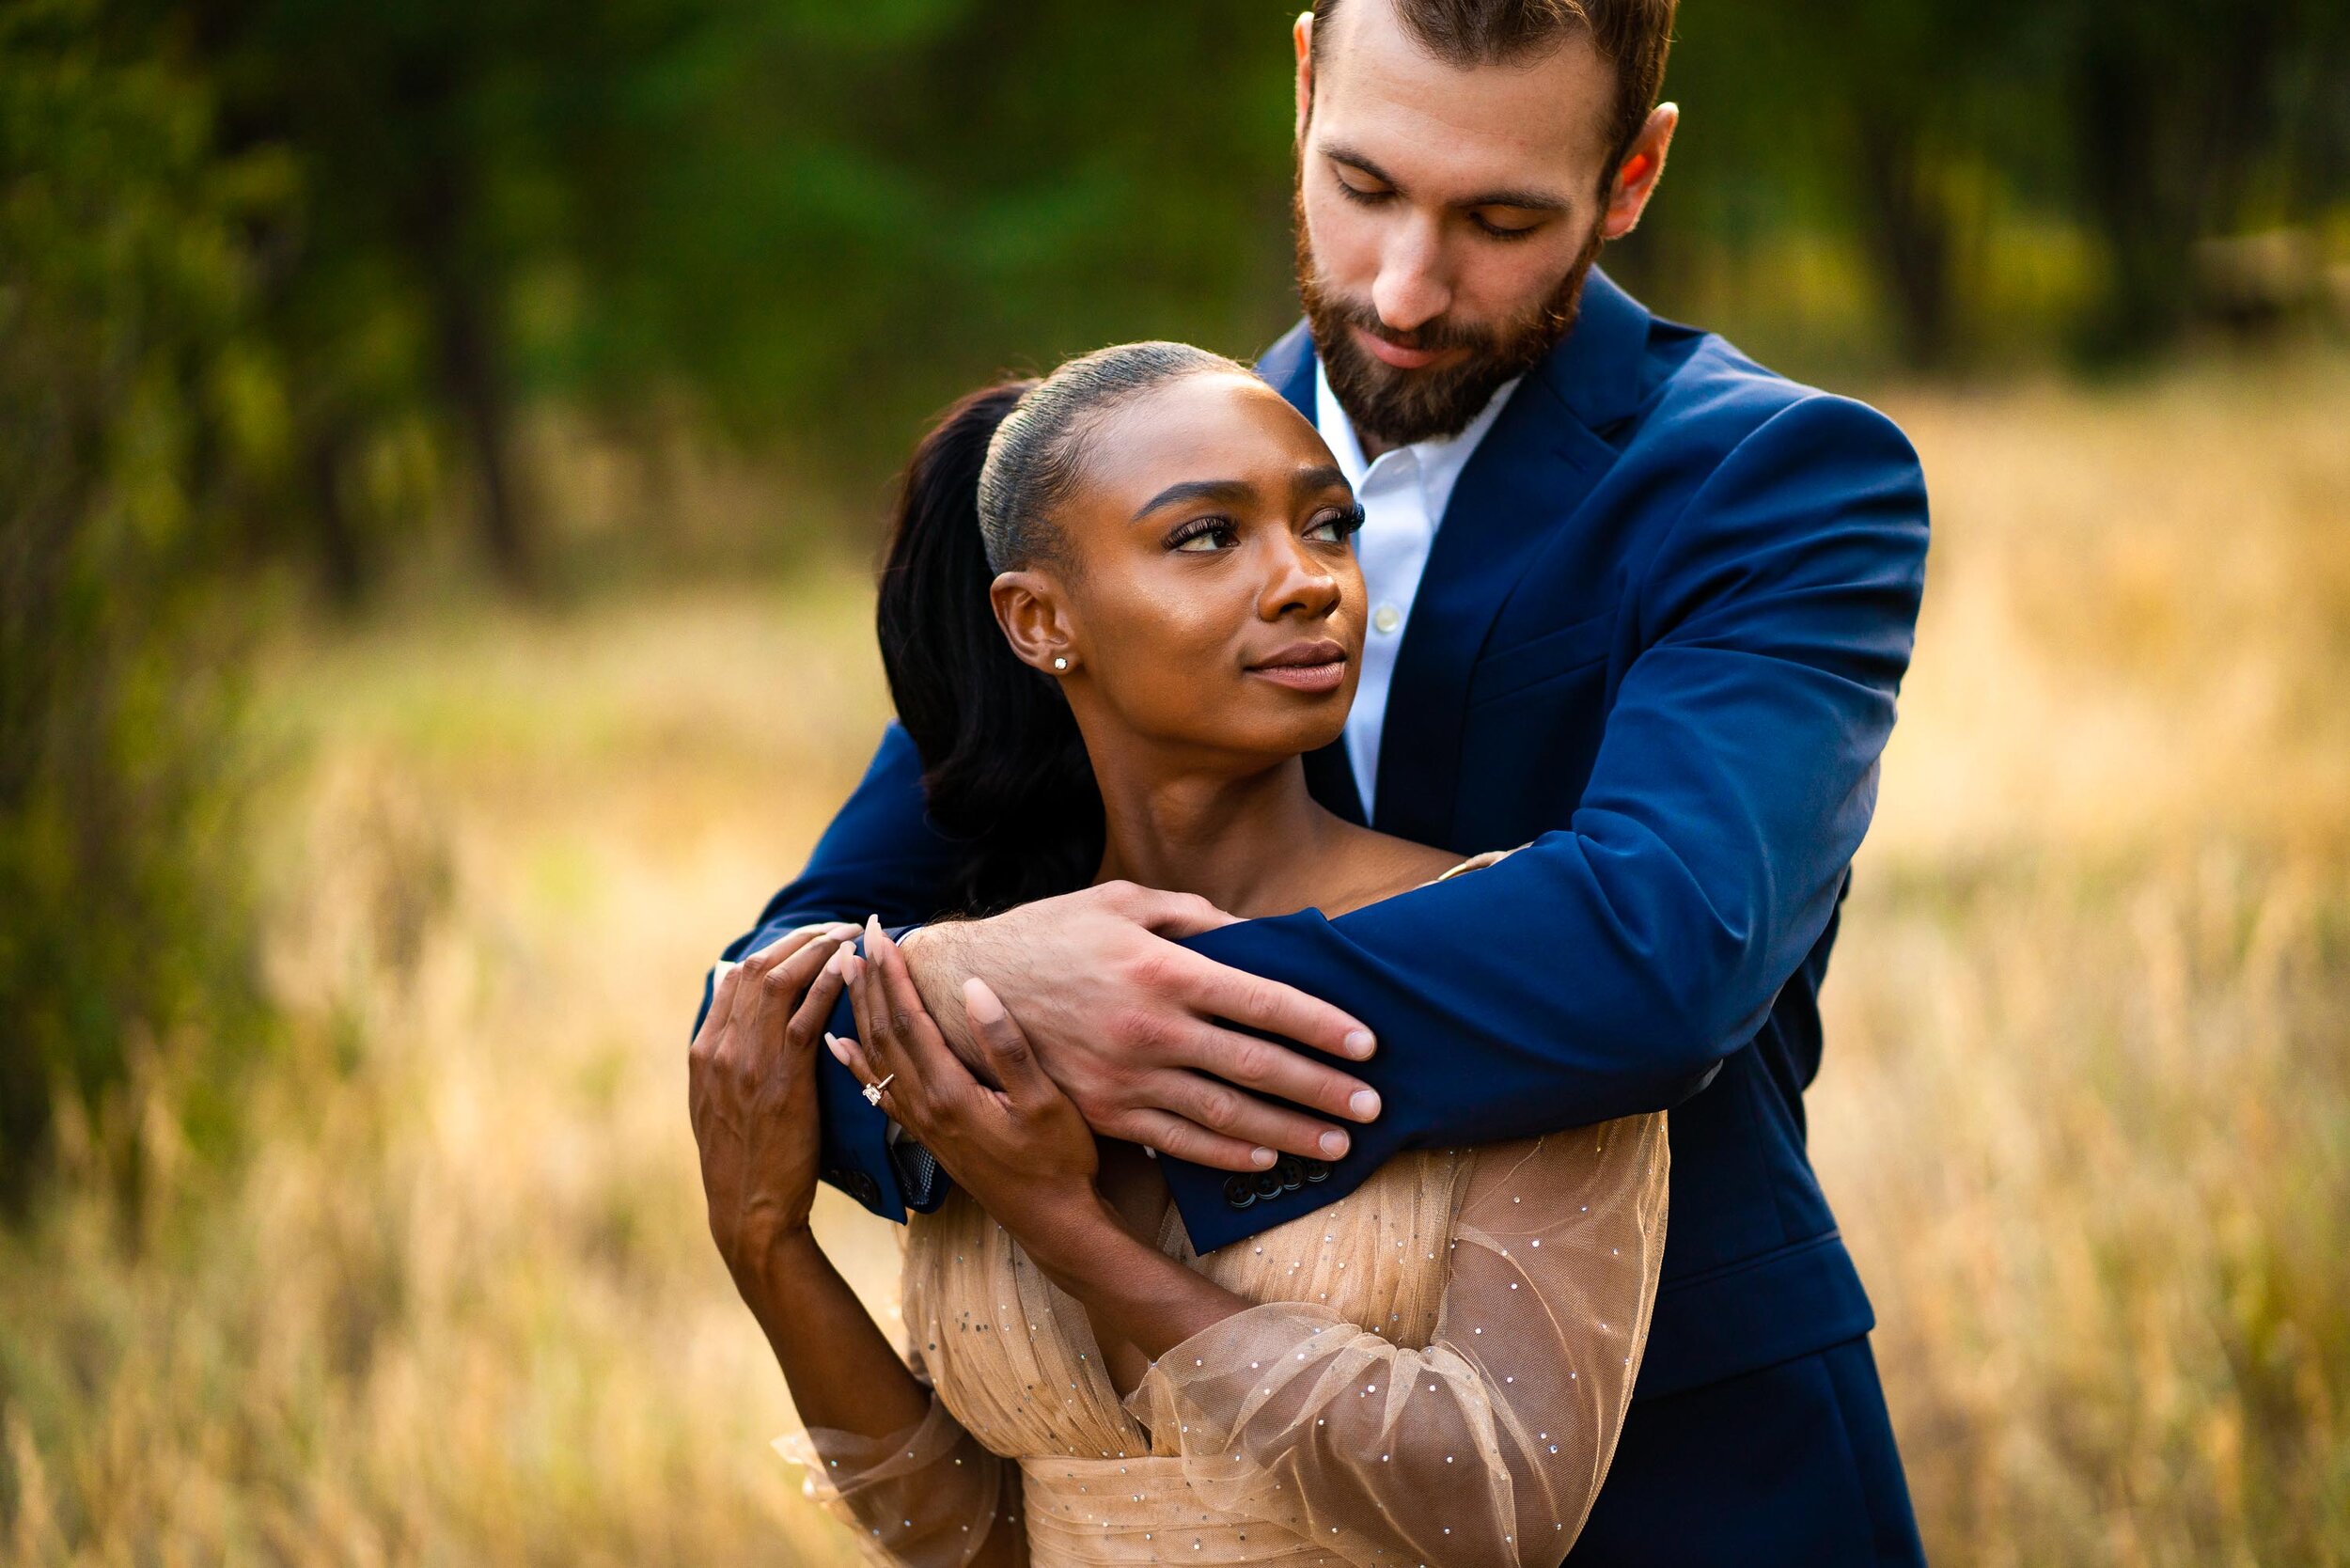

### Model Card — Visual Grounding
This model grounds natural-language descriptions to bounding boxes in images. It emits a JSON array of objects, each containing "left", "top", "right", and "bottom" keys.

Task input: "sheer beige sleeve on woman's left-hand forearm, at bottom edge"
[{"left": 776, "top": 1394, "right": 1027, "bottom": 1568}]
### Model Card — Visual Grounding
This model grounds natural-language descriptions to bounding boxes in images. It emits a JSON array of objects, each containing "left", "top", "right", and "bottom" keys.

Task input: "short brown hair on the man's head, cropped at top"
[{"left": 1314, "top": 0, "right": 1678, "bottom": 181}]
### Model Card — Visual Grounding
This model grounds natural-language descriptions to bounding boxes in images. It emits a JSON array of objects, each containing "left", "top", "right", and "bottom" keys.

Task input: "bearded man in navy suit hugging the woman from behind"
[{"left": 705, "top": 0, "right": 1927, "bottom": 1568}]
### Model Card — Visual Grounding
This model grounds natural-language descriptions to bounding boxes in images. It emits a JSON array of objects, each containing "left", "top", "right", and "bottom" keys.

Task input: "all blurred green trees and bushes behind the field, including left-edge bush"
[{"left": 0, "top": 0, "right": 2350, "bottom": 1213}]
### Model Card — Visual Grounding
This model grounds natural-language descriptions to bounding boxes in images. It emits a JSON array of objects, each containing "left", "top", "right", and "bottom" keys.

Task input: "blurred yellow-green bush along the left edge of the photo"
[{"left": 0, "top": 0, "right": 282, "bottom": 1206}]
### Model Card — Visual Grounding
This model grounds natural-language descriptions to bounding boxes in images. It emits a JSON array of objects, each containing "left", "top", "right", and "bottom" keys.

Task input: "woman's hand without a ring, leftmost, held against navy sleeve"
[{"left": 686, "top": 924, "right": 855, "bottom": 1309}]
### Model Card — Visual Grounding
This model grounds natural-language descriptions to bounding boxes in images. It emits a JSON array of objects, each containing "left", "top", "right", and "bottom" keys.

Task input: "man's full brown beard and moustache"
[{"left": 1291, "top": 180, "right": 1603, "bottom": 447}]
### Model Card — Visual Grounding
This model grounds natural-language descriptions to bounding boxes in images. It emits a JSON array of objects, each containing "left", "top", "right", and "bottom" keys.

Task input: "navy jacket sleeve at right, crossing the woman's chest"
[{"left": 1168, "top": 395, "right": 1927, "bottom": 1250}]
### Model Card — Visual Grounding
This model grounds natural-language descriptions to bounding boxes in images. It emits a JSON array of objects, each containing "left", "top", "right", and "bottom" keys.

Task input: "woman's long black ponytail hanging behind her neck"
[{"left": 874, "top": 381, "right": 1103, "bottom": 915}]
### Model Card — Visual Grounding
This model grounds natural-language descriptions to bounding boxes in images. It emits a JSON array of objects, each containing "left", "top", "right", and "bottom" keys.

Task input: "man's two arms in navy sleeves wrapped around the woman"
[{"left": 714, "top": 385, "right": 1927, "bottom": 1246}]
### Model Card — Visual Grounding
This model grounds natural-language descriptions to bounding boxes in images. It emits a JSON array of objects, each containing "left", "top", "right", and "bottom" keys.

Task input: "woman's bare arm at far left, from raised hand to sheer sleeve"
[{"left": 689, "top": 926, "right": 1025, "bottom": 1568}]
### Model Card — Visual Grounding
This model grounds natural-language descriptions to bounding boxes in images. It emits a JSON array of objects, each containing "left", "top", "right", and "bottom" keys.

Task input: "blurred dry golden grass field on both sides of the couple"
[{"left": 0, "top": 360, "right": 2350, "bottom": 1565}]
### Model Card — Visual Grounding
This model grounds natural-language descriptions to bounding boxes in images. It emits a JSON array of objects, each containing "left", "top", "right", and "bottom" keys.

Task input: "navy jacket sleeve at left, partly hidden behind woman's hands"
[{"left": 694, "top": 724, "right": 954, "bottom": 1220}]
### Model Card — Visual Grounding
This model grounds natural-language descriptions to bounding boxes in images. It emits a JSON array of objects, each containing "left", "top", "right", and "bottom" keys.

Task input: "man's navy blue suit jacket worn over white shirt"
[{"left": 727, "top": 271, "right": 1927, "bottom": 1396}]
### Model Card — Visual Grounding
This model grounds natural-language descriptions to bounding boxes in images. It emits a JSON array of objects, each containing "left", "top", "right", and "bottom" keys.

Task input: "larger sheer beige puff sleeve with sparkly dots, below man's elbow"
[{"left": 1128, "top": 1114, "right": 1668, "bottom": 1568}]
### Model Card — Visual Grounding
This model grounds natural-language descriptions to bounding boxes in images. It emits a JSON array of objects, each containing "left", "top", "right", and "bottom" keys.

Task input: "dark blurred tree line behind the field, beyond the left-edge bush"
[{"left": 8, "top": 0, "right": 2350, "bottom": 602}]
